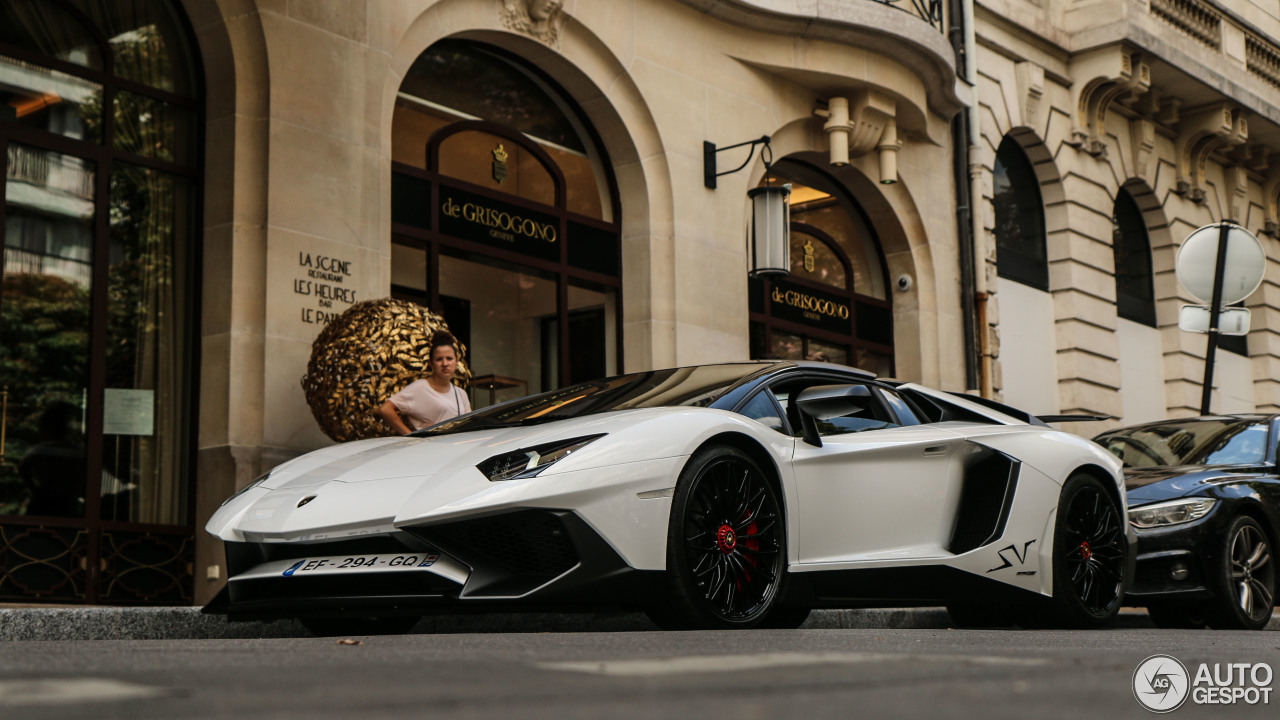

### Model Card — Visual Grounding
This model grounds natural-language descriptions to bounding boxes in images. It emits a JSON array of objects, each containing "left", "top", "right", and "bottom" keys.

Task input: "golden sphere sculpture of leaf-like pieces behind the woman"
[{"left": 302, "top": 297, "right": 471, "bottom": 442}]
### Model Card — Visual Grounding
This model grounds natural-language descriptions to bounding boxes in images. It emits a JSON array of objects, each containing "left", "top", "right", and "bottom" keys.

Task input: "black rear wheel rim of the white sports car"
[{"left": 1064, "top": 487, "right": 1125, "bottom": 615}]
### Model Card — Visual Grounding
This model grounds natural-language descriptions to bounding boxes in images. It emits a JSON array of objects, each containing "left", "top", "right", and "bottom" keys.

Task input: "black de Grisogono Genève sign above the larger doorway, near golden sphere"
[{"left": 440, "top": 186, "right": 561, "bottom": 261}]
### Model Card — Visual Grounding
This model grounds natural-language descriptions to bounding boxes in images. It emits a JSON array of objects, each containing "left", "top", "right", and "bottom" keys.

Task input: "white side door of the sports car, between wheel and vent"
[{"left": 787, "top": 379, "right": 973, "bottom": 564}]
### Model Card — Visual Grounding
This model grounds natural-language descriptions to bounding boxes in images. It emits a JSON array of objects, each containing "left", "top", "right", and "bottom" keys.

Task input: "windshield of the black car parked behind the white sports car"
[{"left": 1093, "top": 418, "right": 1268, "bottom": 468}]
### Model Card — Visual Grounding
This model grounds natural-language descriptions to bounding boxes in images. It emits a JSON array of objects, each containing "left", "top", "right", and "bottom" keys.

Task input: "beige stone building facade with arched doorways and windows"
[{"left": 0, "top": 0, "right": 1280, "bottom": 603}]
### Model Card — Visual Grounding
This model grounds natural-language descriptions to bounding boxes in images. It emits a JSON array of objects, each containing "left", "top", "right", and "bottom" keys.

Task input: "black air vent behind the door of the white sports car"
[{"left": 947, "top": 446, "right": 1020, "bottom": 555}]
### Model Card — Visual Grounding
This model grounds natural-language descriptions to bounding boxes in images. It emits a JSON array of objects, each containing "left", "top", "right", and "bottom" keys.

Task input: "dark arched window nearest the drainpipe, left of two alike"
[{"left": 992, "top": 136, "right": 1048, "bottom": 291}]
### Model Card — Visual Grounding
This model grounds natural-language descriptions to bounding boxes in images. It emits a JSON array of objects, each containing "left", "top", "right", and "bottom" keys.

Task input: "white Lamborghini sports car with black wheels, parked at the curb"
[{"left": 206, "top": 361, "right": 1134, "bottom": 633}]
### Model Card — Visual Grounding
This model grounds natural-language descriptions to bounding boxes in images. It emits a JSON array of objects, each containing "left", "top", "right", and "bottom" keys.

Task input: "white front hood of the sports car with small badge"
[{"left": 206, "top": 407, "right": 727, "bottom": 542}]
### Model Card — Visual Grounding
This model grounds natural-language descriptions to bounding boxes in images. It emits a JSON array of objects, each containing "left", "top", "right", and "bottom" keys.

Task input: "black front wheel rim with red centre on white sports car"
[{"left": 684, "top": 459, "right": 782, "bottom": 621}]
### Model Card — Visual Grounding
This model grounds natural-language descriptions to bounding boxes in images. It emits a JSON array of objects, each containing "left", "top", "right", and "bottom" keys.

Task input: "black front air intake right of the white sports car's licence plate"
[{"left": 421, "top": 510, "right": 579, "bottom": 578}]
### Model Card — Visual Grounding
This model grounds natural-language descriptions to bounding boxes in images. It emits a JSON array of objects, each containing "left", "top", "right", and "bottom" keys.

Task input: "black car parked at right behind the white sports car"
[{"left": 1093, "top": 415, "right": 1280, "bottom": 630}]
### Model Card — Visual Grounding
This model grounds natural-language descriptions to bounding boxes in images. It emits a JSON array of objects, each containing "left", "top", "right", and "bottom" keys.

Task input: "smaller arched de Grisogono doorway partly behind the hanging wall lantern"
[{"left": 749, "top": 160, "right": 893, "bottom": 377}]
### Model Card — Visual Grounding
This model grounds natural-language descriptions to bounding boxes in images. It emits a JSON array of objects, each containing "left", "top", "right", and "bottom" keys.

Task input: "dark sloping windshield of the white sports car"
[{"left": 412, "top": 363, "right": 763, "bottom": 437}]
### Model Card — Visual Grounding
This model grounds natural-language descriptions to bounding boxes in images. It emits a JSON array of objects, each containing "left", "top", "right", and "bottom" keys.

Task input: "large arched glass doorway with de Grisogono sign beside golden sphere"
[{"left": 392, "top": 40, "right": 622, "bottom": 407}]
